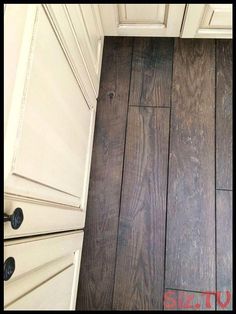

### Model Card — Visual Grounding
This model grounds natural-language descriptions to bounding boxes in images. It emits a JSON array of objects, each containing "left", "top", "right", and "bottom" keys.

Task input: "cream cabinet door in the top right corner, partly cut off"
[{"left": 181, "top": 4, "right": 232, "bottom": 38}]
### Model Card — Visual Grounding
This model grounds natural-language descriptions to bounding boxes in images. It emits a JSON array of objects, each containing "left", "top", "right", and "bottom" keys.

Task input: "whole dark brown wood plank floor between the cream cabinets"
[{"left": 77, "top": 37, "right": 232, "bottom": 310}]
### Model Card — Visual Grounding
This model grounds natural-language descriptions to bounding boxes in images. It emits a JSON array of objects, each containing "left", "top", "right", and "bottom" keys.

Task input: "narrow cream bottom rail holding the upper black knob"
[{"left": 4, "top": 196, "right": 85, "bottom": 239}]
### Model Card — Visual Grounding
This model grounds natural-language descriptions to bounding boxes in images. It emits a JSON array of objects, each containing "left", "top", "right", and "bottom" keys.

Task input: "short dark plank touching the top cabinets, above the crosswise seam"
[{"left": 129, "top": 37, "right": 174, "bottom": 107}]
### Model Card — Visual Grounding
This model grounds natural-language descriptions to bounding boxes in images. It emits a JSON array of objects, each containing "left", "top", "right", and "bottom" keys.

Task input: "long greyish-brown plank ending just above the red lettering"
[{"left": 166, "top": 39, "right": 215, "bottom": 291}]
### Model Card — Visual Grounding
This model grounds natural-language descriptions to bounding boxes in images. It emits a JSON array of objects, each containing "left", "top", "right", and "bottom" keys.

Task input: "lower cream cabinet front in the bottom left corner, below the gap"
[{"left": 4, "top": 231, "right": 83, "bottom": 310}]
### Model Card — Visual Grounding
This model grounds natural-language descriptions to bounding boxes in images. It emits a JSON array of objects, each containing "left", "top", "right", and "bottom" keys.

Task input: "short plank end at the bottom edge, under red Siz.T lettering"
[{"left": 164, "top": 289, "right": 215, "bottom": 311}]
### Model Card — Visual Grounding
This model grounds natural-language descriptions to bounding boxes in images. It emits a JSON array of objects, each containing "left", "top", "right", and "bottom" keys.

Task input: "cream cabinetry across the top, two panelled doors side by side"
[{"left": 99, "top": 4, "right": 232, "bottom": 38}]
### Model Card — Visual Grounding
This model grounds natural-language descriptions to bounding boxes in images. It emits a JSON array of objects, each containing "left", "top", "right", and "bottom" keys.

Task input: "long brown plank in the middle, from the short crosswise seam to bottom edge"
[{"left": 113, "top": 107, "right": 169, "bottom": 310}]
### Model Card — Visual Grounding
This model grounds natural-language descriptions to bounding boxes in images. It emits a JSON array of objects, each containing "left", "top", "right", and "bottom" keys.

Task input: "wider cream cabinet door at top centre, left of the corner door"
[{"left": 99, "top": 4, "right": 185, "bottom": 37}]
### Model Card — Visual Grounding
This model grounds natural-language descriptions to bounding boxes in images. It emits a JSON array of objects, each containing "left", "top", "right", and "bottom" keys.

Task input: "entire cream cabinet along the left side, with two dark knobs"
[{"left": 4, "top": 4, "right": 104, "bottom": 310}]
